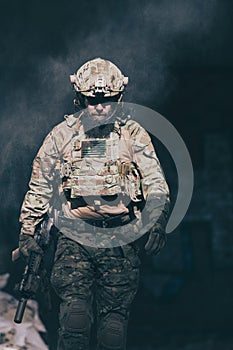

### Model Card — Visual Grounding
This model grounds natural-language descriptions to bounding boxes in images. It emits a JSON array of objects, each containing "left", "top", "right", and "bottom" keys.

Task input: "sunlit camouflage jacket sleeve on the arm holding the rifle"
[{"left": 19, "top": 132, "right": 58, "bottom": 235}]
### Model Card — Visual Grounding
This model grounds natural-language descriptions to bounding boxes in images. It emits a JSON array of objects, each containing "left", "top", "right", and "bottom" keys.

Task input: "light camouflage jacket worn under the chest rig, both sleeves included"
[{"left": 20, "top": 112, "right": 169, "bottom": 235}]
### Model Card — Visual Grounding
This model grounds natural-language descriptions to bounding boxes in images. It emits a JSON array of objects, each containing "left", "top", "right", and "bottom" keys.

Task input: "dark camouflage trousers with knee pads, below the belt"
[{"left": 51, "top": 233, "right": 140, "bottom": 350}]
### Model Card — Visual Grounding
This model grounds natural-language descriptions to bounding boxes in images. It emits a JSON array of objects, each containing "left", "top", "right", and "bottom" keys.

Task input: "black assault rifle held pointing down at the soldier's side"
[{"left": 12, "top": 215, "right": 53, "bottom": 323}]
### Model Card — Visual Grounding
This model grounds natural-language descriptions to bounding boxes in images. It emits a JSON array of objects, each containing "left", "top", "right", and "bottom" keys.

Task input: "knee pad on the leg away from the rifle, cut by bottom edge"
[{"left": 98, "top": 313, "right": 127, "bottom": 350}]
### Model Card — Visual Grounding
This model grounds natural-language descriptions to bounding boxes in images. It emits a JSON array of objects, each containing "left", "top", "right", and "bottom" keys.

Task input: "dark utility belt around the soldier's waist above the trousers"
[{"left": 57, "top": 213, "right": 134, "bottom": 232}]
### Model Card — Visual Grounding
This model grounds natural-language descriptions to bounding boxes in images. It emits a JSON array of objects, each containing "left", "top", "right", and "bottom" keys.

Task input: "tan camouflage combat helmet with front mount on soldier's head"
[{"left": 70, "top": 58, "right": 128, "bottom": 108}]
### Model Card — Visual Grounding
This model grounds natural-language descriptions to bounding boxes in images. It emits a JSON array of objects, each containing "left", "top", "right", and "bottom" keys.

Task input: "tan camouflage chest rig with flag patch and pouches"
[{"left": 60, "top": 122, "right": 142, "bottom": 202}]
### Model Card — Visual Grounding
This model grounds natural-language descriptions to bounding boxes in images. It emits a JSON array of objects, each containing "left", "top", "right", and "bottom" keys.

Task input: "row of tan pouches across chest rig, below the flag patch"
[{"left": 61, "top": 160, "right": 143, "bottom": 202}]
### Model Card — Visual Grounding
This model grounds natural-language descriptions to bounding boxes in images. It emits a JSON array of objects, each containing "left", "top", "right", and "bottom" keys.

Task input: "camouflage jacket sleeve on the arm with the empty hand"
[{"left": 131, "top": 123, "right": 170, "bottom": 229}]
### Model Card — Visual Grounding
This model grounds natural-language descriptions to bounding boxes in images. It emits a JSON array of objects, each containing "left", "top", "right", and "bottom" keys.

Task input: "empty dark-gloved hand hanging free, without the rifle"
[{"left": 145, "top": 223, "right": 167, "bottom": 255}]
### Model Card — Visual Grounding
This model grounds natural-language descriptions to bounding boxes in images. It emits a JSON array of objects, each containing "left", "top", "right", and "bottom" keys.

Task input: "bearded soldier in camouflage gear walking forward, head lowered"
[{"left": 19, "top": 58, "right": 169, "bottom": 350}]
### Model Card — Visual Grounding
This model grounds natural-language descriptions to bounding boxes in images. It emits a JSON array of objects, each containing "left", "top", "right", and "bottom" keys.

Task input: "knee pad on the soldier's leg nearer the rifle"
[{"left": 61, "top": 300, "right": 91, "bottom": 333}]
